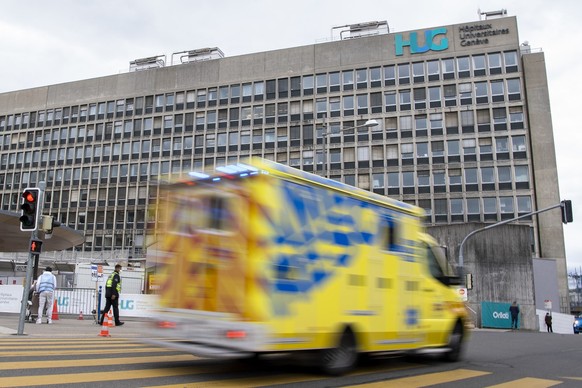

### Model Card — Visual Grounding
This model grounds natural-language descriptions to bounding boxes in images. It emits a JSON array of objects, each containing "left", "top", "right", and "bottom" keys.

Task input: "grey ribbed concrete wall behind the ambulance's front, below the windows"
[{"left": 428, "top": 224, "right": 543, "bottom": 330}]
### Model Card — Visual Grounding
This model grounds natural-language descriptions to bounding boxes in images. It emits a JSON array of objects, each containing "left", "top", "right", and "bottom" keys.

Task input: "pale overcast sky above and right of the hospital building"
[{"left": 0, "top": 0, "right": 582, "bottom": 272}]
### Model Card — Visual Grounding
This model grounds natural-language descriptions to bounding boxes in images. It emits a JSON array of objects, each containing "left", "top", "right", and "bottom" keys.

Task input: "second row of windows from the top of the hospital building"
[{"left": 0, "top": 78, "right": 521, "bottom": 136}]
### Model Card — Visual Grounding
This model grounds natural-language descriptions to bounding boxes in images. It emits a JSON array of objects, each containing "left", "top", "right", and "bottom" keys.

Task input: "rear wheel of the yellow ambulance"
[{"left": 321, "top": 329, "right": 358, "bottom": 376}]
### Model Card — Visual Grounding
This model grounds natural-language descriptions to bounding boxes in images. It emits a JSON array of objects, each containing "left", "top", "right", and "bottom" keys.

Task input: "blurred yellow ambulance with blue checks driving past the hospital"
[{"left": 147, "top": 159, "right": 467, "bottom": 374}]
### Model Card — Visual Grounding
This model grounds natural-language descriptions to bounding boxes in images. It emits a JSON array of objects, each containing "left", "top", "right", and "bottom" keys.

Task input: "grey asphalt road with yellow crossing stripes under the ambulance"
[{"left": 0, "top": 319, "right": 582, "bottom": 388}]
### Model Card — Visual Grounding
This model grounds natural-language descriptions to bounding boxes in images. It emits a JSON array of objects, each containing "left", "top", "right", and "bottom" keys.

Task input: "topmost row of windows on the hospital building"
[{"left": 0, "top": 51, "right": 518, "bottom": 131}]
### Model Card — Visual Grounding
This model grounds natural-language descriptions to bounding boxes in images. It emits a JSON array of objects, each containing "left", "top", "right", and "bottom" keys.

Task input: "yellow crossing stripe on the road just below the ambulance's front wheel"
[{"left": 350, "top": 369, "right": 491, "bottom": 388}]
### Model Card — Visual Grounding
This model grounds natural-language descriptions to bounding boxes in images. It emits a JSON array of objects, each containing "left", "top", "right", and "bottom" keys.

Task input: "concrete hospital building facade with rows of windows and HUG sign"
[{"left": 0, "top": 17, "right": 567, "bottom": 312}]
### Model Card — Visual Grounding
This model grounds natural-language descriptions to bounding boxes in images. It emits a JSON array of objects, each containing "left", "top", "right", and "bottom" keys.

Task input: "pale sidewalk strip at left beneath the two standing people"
[{"left": 0, "top": 313, "right": 146, "bottom": 338}]
